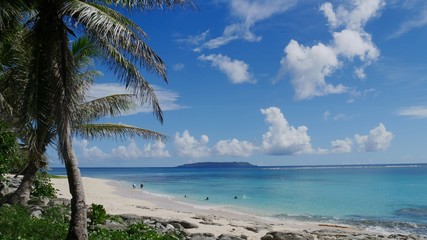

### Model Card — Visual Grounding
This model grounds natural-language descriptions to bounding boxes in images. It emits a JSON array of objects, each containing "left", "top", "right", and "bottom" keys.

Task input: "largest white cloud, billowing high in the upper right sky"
[{"left": 277, "top": 0, "right": 385, "bottom": 100}]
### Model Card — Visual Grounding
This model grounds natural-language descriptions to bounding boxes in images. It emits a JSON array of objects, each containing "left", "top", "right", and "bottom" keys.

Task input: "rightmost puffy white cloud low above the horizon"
[{"left": 354, "top": 123, "right": 393, "bottom": 152}]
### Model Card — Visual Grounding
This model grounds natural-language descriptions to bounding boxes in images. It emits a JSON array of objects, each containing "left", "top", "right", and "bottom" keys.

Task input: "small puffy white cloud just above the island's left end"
[{"left": 174, "top": 130, "right": 211, "bottom": 158}]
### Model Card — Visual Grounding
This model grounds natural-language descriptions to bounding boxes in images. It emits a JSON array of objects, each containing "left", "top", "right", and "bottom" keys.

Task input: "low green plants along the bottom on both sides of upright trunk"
[{"left": 0, "top": 205, "right": 185, "bottom": 240}]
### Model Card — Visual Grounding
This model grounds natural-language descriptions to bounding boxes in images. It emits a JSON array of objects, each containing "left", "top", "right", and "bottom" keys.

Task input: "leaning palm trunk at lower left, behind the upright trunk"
[{"left": 0, "top": 161, "right": 39, "bottom": 205}]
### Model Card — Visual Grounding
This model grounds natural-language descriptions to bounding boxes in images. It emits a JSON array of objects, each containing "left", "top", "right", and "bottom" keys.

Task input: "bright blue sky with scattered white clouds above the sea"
[{"left": 50, "top": 0, "right": 427, "bottom": 167}]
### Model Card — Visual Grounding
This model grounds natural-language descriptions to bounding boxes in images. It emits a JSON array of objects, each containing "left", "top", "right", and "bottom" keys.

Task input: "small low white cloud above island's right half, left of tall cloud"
[{"left": 214, "top": 138, "right": 258, "bottom": 157}]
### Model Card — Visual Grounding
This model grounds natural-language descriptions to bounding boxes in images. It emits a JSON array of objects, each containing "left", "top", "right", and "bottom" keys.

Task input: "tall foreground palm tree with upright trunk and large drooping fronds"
[{"left": 3, "top": 0, "right": 192, "bottom": 239}]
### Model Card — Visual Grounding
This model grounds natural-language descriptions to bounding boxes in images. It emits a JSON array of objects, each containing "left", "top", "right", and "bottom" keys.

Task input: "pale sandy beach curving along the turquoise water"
[{"left": 52, "top": 177, "right": 382, "bottom": 240}]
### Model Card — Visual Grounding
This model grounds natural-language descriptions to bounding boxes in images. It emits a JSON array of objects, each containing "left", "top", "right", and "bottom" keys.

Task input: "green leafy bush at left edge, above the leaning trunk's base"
[{"left": 0, "top": 121, "right": 19, "bottom": 181}]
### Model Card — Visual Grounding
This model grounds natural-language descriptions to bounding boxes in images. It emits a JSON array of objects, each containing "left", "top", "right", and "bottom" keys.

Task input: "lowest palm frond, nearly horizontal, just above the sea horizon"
[{"left": 73, "top": 123, "right": 167, "bottom": 141}]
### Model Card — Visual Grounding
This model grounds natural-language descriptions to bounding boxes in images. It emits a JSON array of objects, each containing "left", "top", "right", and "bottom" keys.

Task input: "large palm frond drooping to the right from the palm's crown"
[{"left": 64, "top": 1, "right": 166, "bottom": 122}]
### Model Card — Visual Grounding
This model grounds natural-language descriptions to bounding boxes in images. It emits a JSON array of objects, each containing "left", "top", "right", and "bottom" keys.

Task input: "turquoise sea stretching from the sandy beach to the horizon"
[{"left": 49, "top": 164, "right": 427, "bottom": 235}]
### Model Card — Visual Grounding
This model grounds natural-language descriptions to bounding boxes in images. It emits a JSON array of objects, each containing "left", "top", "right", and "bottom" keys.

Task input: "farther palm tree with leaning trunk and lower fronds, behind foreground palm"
[{"left": 0, "top": 37, "right": 165, "bottom": 204}]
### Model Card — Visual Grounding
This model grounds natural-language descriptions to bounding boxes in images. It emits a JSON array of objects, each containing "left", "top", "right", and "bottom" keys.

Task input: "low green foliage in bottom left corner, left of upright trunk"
[{"left": 0, "top": 205, "right": 68, "bottom": 240}]
